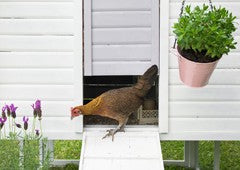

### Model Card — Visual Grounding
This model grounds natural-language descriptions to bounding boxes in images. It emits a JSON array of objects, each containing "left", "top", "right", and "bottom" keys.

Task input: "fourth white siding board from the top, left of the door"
[{"left": 0, "top": 52, "right": 74, "bottom": 69}]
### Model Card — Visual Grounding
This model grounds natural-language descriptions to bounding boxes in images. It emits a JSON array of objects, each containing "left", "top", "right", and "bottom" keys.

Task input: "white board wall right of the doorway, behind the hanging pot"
[{"left": 159, "top": 0, "right": 240, "bottom": 140}]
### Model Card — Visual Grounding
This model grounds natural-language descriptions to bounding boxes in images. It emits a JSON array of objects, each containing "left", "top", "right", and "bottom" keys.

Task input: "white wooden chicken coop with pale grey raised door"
[{"left": 0, "top": 0, "right": 240, "bottom": 168}]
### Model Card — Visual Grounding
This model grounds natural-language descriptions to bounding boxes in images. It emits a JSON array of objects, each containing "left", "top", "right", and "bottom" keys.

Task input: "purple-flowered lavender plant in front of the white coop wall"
[{"left": 0, "top": 100, "right": 51, "bottom": 169}]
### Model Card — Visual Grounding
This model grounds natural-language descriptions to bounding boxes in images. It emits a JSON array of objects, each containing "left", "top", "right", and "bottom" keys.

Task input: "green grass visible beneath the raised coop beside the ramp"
[{"left": 52, "top": 141, "right": 240, "bottom": 170}]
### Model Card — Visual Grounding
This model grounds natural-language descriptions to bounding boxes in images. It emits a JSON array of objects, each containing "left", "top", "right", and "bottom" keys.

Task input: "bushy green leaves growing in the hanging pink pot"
[{"left": 173, "top": 5, "right": 237, "bottom": 58}]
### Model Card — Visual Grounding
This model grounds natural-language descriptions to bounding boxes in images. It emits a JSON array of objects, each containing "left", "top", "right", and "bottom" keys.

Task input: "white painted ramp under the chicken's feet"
[{"left": 79, "top": 132, "right": 164, "bottom": 170}]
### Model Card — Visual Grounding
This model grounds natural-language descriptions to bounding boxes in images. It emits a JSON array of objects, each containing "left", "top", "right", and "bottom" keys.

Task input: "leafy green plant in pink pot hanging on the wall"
[{"left": 173, "top": 4, "right": 237, "bottom": 87}]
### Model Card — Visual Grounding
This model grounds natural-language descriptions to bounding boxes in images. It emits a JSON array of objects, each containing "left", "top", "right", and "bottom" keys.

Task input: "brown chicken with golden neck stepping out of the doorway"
[{"left": 71, "top": 65, "right": 158, "bottom": 140}]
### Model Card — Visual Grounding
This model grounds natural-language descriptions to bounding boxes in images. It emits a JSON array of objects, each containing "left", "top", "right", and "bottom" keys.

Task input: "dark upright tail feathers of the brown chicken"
[{"left": 135, "top": 65, "right": 158, "bottom": 91}]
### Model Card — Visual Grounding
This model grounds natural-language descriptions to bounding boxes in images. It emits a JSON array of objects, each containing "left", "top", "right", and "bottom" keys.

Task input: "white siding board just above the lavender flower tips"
[{"left": 0, "top": 84, "right": 74, "bottom": 101}]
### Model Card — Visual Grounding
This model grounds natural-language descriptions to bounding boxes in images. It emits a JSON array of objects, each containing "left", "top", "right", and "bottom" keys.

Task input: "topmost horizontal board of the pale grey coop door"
[{"left": 92, "top": 0, "right": 151, "bottom": 11}]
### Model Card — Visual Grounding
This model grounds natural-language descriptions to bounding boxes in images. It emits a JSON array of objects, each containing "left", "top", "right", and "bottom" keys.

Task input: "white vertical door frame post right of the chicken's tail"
[{"left": 158, "top": 0, "right": 170, "bottom": 133}]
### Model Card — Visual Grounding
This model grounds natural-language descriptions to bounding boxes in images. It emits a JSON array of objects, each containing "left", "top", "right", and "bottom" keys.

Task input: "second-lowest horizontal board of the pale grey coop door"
[{"left": 93, "top": 44, "right": 151, "bottom": 62}]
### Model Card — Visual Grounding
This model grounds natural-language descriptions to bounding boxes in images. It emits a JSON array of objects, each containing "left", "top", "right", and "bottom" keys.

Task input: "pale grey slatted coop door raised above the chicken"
[{"left": 84, "top": 0, "right": 159, "bottom": 76}]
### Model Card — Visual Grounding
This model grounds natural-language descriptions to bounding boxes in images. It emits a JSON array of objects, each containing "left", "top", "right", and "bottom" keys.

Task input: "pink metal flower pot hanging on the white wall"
[{"left": 172, "top": 48, "right": 219, "bottom": 88}]
